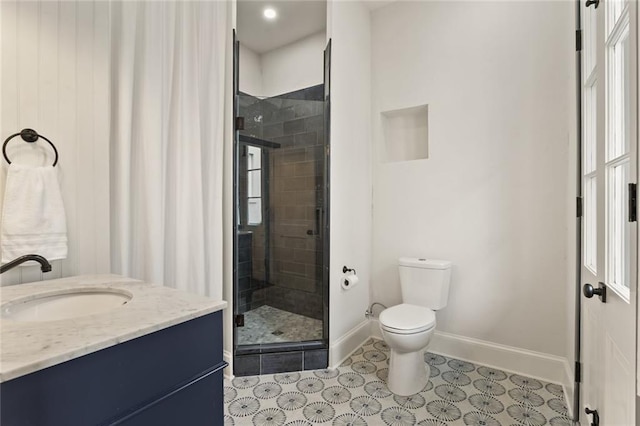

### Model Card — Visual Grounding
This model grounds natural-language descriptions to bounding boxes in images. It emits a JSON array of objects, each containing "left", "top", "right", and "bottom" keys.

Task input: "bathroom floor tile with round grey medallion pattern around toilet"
[{"left": 224, "top": 339, "right": 572, "bottom": 426}]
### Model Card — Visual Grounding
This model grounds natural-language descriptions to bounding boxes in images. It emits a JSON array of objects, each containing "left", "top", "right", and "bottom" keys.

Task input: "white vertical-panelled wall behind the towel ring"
[{"left": 0, "top": 1, "right": 110, "bottom": 285}]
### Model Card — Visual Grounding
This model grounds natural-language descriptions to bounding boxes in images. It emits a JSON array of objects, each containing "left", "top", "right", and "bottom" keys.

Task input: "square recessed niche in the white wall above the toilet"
[{"left": 381, "top": 104, "right": 429, "bottom": 163}]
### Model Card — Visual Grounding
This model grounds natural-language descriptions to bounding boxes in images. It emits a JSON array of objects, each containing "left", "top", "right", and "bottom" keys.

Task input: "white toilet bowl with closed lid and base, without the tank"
[{"left": 379, "top": 303, "right": 436, "bottom": 396}]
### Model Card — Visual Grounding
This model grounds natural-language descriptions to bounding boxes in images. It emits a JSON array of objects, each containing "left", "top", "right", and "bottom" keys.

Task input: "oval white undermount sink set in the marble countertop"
[{"left": 0, "top": 288, "right": 132, "bottom": 321}]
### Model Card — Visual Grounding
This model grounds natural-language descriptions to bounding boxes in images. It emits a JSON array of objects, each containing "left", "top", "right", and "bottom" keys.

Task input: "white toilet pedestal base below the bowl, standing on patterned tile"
[{"left": 387, "top": 349, "right": 431, "bottom": 396}]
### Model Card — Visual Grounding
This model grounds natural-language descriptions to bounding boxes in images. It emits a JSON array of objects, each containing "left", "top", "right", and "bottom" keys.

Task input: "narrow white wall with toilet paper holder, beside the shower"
[{"left": 328, "top": 1, "right": 372, "bottom": 365}]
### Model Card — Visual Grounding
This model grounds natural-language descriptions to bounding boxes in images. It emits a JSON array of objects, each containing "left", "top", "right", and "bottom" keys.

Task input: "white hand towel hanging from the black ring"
[{"left": 0, "top": 163, "right": 67, "bottom": 263}]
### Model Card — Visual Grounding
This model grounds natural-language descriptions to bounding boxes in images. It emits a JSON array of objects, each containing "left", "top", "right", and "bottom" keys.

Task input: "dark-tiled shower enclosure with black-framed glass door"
[{"left": 234, "top": 85, "right": 328, "bottom": 376}]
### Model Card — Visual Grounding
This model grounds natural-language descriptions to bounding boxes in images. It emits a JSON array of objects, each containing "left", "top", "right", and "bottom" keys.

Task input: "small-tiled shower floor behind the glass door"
[{"left": 236, "top": 305, "right": 322, "bottom": 345}]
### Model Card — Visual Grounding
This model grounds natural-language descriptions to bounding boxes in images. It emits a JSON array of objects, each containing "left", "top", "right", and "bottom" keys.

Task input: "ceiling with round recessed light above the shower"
[{"left": 237, "top": 0, "right": 327, "bottom": 54}]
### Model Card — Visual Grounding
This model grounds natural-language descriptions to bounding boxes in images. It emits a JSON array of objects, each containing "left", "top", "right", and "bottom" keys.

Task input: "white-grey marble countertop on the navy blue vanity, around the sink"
[{"left": 0, "top": 275, "right": 227, "bottom": 382}]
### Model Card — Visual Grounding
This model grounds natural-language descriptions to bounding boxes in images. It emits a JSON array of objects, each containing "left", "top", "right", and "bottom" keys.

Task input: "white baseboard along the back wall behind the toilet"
[{"left": 370, "top": 318, "right": 573, "bottom": 394}]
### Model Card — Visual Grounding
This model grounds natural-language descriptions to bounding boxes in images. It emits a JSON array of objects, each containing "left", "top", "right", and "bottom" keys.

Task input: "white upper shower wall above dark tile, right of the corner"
[{"left": 262, "top": 32, "right": 326, "bottom": 96}]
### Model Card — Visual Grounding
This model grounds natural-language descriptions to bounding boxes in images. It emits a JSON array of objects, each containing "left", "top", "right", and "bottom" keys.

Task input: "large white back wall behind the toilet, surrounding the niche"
[{"left": 370, "top": 2, "right": 575, "bottom": 356}]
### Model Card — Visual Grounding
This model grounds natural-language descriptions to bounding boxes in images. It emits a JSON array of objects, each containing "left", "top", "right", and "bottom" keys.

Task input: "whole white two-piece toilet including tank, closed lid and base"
[{"left": 379, "top": 257, "right": 451, "bottom": 396}]
